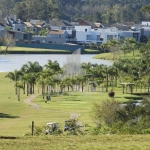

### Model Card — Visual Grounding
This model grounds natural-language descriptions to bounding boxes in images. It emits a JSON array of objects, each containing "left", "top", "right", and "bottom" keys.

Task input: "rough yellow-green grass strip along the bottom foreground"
[{"left": 0, "top": 135, "right": 150, "bottom": 150}]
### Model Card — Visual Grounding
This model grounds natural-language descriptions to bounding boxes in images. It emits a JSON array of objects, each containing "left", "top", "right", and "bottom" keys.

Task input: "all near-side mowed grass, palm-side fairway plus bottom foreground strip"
[{"left": 0, "top": 73, "right": 150, "bottom": 150}]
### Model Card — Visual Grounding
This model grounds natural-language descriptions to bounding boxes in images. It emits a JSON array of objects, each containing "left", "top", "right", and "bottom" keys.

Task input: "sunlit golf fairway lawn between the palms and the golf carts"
[{"left": 0, "top": 73, "right": 145, "bottom": 136}]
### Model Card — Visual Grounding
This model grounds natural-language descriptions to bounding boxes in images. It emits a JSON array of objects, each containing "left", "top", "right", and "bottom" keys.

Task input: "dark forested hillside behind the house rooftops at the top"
[{"left": 0, "top": 0, "right": 150, "bottom": 24}]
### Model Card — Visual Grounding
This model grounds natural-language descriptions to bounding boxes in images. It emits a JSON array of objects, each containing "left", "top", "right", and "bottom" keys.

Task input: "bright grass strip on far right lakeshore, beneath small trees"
[{"left": 94, "top": 51, "right": 140, "bottom": 60}]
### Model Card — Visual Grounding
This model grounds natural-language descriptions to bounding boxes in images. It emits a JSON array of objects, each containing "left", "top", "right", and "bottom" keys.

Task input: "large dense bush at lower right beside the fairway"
[{"left": 91, "top": 100, "right": 150, "bottom": 134}]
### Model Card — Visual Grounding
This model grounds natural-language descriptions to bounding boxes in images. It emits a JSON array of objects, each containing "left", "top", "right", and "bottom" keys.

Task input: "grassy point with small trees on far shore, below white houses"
[{"left": 94, "top": 38, "right": 144, "bottom": 60}]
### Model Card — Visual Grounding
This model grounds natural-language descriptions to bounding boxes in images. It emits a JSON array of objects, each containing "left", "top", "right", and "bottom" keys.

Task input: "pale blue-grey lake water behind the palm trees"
[{"left": 0, "top": 54, "right": 112, "bottom": 72}]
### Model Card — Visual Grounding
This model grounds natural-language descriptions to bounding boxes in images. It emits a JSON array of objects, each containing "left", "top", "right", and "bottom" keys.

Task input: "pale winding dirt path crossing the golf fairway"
[{"left": 24, "top": 94, "right": 81, "bottom": 119}]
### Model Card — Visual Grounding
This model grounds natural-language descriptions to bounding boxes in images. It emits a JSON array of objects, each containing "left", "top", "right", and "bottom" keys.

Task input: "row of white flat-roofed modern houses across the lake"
[{"left": 75, "top": 26, "right": 141, "bottom": 44}]
